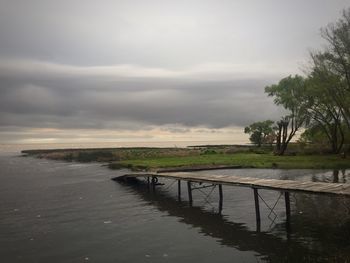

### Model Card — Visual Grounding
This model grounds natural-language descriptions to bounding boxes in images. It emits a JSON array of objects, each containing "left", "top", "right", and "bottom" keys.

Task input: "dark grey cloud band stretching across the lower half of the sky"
[{"left": 0, "top": 61, "right": 284, "bottom": 133}]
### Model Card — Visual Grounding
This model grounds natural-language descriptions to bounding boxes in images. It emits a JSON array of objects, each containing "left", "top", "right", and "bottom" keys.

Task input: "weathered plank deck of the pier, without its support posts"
[{"left": 114, "top": 172, "right": 350, "bottom": 196}]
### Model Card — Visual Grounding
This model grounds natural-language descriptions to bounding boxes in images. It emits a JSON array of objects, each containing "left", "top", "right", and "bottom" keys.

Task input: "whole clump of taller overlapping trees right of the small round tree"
[{"left": 265, "top": 8, "right": 350, "bottom": 155}]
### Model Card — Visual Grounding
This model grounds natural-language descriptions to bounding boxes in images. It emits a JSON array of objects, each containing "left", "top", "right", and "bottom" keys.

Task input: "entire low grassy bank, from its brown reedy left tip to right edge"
[{"left": 23, "top": 146, "right": 350, "bottom": 170}]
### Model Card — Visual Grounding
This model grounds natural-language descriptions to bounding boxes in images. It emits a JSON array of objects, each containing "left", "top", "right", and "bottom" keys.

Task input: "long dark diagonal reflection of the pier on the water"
[{"left": 121, "top": 182, "right": 310, "bottom": 261}]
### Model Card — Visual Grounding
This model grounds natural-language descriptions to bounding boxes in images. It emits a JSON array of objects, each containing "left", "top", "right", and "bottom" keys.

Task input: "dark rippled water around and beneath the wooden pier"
[{"left": 0, "top": 153, "right": 350, "bottom": 262}]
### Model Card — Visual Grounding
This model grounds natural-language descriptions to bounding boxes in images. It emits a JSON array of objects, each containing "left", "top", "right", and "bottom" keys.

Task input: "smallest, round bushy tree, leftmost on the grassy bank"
[{"left": 244, "top": 120, "right": 275, "bottom": 147}]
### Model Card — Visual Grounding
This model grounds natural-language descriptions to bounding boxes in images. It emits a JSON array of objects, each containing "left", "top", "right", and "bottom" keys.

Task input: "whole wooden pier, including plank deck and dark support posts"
[{"left": 113, "top": 172, "right": 350, "bottom": 229}]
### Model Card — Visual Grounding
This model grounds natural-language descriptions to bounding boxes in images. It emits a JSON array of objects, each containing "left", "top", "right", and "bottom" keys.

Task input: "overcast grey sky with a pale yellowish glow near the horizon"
[{"left": 0, "top": 0, "right": 350, "bottom": 144}]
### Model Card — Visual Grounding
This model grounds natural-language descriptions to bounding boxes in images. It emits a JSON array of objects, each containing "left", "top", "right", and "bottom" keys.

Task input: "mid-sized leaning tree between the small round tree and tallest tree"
[{"left": 265, "top": 75, "right": 308, "bottom": 155}]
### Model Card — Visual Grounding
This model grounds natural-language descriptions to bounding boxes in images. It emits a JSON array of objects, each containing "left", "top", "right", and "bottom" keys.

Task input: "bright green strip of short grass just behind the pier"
[{"left": 110, "top": 153, "right": 350, "bottom": 170}]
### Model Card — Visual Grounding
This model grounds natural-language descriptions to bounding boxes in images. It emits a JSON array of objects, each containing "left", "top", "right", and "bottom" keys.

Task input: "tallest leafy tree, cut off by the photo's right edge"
[{"left": 307, "top": 8, "right": 350, "bottom": 153}]
